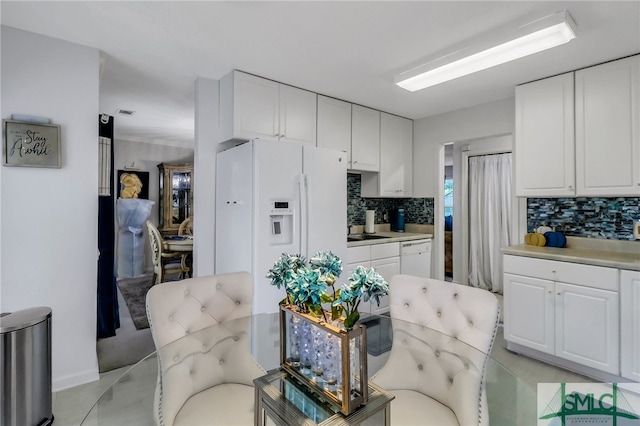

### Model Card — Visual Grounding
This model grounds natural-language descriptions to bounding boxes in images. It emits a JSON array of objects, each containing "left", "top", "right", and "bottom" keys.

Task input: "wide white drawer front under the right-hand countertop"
[{"left": 504, "top": 256, "right": 618, "bottom": 291}]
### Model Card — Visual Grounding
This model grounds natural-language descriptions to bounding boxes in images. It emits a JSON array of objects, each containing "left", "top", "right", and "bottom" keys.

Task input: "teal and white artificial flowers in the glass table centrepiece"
[{"left": 267, "top": 251, "right": 389, "bottom": 330}]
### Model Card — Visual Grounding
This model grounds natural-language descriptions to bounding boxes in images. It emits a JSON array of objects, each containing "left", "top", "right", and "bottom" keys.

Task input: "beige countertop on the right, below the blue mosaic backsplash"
[{"left": 502, "top": 237, "right": 640, "bottom": 271}]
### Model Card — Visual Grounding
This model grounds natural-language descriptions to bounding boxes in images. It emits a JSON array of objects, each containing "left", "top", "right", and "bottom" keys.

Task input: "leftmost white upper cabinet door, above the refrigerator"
[{"left": 233, "top": 71, "right": 280, "bottom": 139}]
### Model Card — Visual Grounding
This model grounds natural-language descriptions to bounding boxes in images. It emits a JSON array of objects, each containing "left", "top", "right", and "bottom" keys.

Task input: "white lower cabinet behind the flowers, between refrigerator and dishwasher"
[{"left": 342, "top": 243, "right": 400, "bottom": 315}]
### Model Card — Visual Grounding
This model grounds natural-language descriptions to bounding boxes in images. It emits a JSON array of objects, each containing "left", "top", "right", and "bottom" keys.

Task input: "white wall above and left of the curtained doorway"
[{"left": 413, "top": 98, "right": 515, "bottom": 279}]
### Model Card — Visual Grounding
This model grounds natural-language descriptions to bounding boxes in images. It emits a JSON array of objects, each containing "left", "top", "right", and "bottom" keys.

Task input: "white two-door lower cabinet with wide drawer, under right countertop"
[{"left": 504, "top": 255, "right": 620, "bottom": 375}]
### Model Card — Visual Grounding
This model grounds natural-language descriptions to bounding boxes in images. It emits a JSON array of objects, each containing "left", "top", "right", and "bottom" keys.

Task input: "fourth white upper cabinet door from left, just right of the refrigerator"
[{"left": 351, "top": 105, "right": 380, "bottom": 172}]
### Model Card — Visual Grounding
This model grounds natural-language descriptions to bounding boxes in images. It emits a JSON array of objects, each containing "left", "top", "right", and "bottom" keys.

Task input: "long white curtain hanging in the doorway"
[{"left": 469, "top": 153, "right": 511, "bottom": 293}]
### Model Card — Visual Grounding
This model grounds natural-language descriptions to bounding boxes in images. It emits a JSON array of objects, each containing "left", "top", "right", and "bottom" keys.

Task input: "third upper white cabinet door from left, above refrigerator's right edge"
[{"left": 317, "top": 95, "right": 351, "bottom": 161}]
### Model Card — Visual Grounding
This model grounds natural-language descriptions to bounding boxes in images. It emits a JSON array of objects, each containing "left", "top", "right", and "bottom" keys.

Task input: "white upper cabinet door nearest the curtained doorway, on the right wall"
[{"left": 514, "top": 73, "right": 575, "bottom": 197}]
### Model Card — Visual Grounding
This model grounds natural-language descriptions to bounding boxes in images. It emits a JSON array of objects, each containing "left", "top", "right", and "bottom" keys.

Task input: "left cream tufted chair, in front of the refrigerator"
[{"left": 147, "top": 272, "right": 266, "bottom": 426}]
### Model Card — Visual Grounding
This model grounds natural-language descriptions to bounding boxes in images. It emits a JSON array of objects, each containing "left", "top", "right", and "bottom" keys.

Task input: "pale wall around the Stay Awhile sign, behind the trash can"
[{"left": 0, "top": 26, "right": 99, "bottom": 390}]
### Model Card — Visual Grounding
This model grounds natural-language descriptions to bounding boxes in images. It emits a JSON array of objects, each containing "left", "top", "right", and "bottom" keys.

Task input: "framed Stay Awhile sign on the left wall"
[{"left": 2, "top": 120, "right": 61, "bottom": 168}]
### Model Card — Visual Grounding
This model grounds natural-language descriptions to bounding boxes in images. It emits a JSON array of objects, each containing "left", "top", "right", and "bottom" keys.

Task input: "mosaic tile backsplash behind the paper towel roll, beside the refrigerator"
[{"left": 347, "top": 173, "right": 433, "bottom": 225}]
